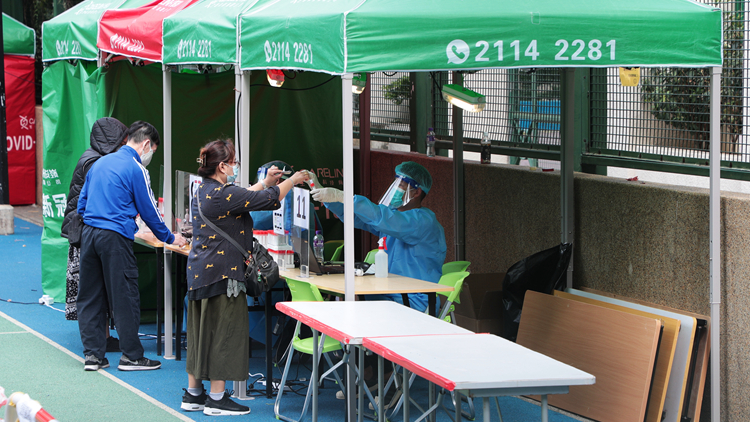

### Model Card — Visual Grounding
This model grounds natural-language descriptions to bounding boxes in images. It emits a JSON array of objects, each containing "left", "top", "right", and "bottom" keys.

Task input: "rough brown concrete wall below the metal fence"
[{"left": 372, "top": 151, "right": 750, "bottom": 421}]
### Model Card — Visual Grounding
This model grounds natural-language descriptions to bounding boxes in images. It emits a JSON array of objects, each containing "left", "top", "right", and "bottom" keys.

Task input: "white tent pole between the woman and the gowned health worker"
[{"left": 341, "top": 73, "right": 354, "bottom": 300}]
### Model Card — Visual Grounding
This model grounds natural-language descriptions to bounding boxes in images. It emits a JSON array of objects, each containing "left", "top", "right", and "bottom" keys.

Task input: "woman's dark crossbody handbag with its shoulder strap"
[{"left": 198, "top": 195, "right": 279, "bottom": 296}]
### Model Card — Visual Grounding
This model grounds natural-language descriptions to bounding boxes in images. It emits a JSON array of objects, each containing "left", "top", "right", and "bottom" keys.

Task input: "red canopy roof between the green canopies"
[{"left": 96, "top": 0, "right": 198, "bottom": 62}]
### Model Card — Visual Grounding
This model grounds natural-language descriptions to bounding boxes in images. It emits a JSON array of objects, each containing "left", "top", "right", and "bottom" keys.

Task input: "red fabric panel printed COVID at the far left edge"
[{"left": 4, "top": 55, "right": 36, "bottom": 205}]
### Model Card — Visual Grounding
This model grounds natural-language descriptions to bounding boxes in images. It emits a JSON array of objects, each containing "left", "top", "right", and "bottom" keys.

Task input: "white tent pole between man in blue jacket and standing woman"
[{"left": 157, "top": 64, "right": 174, "bottom": 359}]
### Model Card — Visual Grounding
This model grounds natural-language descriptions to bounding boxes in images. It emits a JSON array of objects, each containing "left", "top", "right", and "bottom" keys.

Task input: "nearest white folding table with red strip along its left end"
[{"left": 363, "top": 333, "right": 596, "bottom": 422}]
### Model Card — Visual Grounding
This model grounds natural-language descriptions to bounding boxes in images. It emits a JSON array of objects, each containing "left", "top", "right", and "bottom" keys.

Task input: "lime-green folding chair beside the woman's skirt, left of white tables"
[{"left": 273, "top": 278, "right": 349, "bottom": 422}]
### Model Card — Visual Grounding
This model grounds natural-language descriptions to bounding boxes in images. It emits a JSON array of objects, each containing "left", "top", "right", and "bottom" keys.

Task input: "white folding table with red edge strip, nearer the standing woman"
[{"left": 276, "top": 301, "right": 473, "bottom": 422}]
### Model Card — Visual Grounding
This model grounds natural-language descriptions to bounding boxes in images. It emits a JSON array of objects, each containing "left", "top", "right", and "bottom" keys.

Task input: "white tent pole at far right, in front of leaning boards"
[{"left": 709, "top": 66, "right": 721, "bottom": 422}]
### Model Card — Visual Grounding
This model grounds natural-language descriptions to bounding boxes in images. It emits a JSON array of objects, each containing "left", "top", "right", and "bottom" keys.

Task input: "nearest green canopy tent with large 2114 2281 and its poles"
[{"left": 240, "top": 0, "right": 723, "bottom": 421}]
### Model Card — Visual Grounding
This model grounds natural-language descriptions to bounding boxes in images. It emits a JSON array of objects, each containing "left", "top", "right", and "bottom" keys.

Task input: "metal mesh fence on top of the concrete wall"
[{"left": 355, "top": 0, "right": 750, "bottom": 180}]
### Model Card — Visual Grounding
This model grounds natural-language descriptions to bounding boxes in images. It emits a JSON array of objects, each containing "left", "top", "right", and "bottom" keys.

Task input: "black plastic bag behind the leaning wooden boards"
[{"left": 503, "top": 243, "right": 573, "bottom": 341}]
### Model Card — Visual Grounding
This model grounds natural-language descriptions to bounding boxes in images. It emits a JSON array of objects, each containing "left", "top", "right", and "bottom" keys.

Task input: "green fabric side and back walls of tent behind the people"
[{"left": 42, "top": 61, "right": 343, "bottom": 301}]
